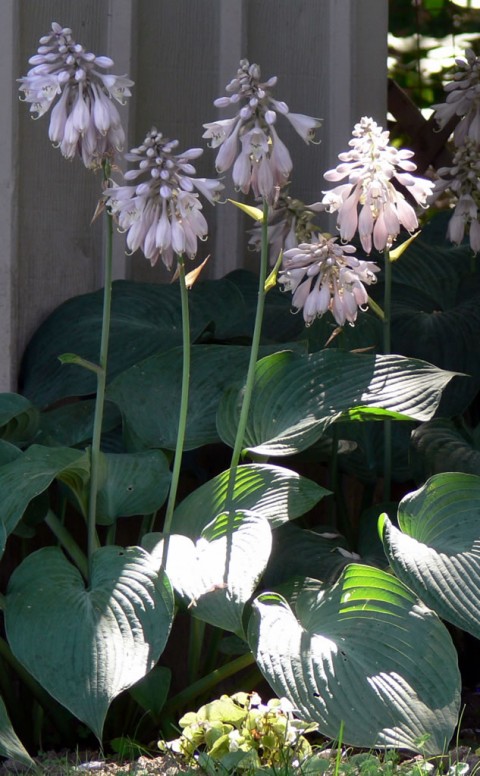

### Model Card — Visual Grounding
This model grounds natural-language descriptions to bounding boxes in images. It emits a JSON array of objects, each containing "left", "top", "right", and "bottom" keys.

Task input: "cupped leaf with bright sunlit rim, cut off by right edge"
[{"left": 381, "top": 473, "right": 480, "bottom": 638}]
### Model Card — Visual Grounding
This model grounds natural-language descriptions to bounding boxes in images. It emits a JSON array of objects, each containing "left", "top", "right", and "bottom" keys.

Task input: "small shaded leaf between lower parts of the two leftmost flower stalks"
[{"left": 97, "top": 450, "right": 171, "bottom": 525}]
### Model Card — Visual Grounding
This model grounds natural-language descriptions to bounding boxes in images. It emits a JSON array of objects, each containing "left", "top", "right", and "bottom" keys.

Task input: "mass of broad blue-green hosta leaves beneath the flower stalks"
[{"left": 0, "top": 223, "right": 479, "bottom": 756}]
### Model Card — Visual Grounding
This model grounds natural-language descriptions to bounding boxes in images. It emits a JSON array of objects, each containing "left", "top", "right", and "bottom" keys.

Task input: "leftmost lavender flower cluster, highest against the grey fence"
[{"left": 19, "top": 22, "right": 133, "bottom": 167}]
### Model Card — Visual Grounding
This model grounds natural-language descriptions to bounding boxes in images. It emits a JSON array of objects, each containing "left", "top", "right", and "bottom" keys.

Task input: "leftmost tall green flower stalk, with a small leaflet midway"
[{"left": 87, "top": 160, "right": 113, "bottom": 577}]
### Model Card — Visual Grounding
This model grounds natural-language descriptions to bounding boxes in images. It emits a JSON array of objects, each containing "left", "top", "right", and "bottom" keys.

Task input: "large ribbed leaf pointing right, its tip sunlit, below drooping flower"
[{"left": 217, "top": 350, "right": 454, "bottom": 456}]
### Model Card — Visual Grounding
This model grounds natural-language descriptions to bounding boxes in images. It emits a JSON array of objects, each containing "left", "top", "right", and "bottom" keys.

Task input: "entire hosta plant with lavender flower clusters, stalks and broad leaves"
[{"left": 0, "top": 23, "right": 480, "bottom": 762}]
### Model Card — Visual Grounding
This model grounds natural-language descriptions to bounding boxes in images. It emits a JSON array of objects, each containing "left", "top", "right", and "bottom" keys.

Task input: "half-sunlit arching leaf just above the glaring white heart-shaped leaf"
[{"left": 172, "top": 464, "right": 330, "bottom": 539}]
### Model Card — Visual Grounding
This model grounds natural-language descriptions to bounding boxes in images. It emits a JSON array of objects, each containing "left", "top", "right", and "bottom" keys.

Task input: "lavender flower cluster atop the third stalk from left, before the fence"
[{"left": 203, "top": 59, "right": 321, "bottom": 201}]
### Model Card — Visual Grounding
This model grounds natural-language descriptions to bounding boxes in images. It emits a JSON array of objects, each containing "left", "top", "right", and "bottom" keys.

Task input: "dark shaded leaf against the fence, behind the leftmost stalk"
[{"left": 21, "top": 281, "right": 181, "bottom": 406}]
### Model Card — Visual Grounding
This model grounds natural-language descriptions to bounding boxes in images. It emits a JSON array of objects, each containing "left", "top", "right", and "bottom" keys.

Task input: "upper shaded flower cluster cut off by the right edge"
[{"left": 432, "top": 49, "right": 480, "bottom": 146}]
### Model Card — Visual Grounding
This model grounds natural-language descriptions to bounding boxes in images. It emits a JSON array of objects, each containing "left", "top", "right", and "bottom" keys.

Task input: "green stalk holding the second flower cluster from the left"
[{"left": 163, "top": 256, "right": 191, "bottom": 536}]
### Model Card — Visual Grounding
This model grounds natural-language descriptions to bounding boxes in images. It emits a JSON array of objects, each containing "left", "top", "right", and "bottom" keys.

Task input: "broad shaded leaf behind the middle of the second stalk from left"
[{"left": 107, "top": 345, "right": 278, "bottom": 450}]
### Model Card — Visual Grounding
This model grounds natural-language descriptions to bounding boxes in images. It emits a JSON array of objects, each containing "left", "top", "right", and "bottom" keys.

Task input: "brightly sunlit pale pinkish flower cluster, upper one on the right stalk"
[{"left": 322, "top": 117, "right": 433, "bottom": 253}]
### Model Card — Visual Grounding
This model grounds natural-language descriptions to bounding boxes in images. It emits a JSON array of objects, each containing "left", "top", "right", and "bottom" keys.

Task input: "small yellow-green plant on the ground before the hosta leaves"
[{"left": 158, "top": 692, "right": 317, "bottom": 773}]
